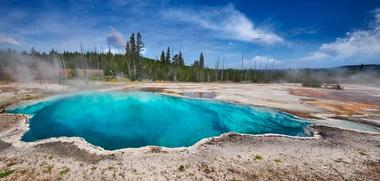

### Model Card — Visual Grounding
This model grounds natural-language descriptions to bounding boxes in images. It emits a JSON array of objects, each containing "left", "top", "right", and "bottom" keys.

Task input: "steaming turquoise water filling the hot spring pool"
[{"left": 8, "top": 92, "right": 308, "bottom": 150}]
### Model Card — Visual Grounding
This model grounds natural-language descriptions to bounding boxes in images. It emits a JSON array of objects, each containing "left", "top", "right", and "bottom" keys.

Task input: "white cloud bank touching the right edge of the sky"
[{"left": 303, "top": 9, "right": 380, "bottom": 60}]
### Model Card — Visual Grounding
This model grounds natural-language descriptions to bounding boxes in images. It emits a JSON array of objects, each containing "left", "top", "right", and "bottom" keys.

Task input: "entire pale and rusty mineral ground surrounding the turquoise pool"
[{"left": 0, "top": 82, "right": 380, "bottom": 180}]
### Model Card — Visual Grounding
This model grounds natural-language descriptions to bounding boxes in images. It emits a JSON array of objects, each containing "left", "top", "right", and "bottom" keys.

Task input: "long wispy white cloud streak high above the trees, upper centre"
[{"left": 161, "top": 5, "right": 284, "bottom": 44}]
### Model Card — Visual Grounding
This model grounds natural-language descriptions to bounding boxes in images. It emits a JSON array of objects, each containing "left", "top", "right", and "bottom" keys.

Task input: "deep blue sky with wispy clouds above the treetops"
[{"left": 0, "top": 0, "right": 380, "bottom": 68}]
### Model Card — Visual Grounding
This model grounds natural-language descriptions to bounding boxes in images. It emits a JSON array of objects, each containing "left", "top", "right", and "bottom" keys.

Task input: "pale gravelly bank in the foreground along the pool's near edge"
[{"left": 0, "top": 114, "right": 380, "bottom": 180}]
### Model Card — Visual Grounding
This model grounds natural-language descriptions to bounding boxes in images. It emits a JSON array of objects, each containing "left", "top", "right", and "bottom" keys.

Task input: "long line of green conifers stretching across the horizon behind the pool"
[{"left": 0, "top": 33, "right": 374, "bottom": 82}]
